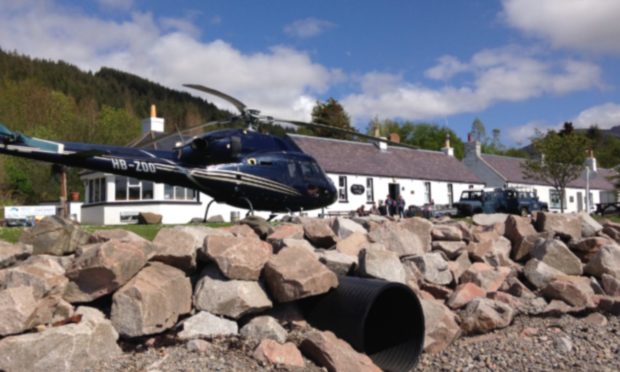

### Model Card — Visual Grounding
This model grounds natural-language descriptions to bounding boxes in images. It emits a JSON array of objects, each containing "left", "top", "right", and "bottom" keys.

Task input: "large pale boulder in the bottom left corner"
[{"left": 0, "top": 307, "right": 122, "bottom": 372}]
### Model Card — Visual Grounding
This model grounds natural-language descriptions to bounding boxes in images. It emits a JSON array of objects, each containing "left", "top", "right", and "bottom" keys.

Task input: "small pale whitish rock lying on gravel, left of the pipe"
[{"left": 178, "top": 311, "right": 239, "bottom": 340}]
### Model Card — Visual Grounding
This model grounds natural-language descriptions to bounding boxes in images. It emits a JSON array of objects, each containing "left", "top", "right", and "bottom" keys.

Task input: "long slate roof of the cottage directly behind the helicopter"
[{"left": 289, "top": 135, "right": 484, "bottom": 184}]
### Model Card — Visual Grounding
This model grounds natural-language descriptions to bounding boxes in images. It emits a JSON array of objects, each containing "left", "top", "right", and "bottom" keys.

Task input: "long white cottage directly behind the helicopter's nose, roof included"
[{"left": 291, "top": 135, "right": 484, "bottom": 212}]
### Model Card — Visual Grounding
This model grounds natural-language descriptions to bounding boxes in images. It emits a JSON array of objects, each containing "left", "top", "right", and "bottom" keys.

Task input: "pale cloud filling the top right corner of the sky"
[{"left": 503, "top": 0, "right": 620, "bottom": 53}]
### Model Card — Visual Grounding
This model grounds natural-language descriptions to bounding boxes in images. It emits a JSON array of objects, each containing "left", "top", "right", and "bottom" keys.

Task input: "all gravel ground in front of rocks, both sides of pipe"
[{"left": 85, "top": 315, "right": 620, "bottom": 372}]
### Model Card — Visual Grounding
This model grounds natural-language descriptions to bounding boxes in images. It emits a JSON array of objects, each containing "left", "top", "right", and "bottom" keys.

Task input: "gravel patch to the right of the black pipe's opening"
[{"left": 417, "top": 315, "right": 620, "bottom": 371}]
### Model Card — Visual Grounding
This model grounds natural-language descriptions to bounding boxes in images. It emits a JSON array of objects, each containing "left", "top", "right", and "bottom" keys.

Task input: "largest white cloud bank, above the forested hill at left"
[{"left": 0, "top": 0, "right": 342, "bottom": 120}]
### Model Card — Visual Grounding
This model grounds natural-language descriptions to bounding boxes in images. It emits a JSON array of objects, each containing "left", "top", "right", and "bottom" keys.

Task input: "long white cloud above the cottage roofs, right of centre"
[{"left": 342, "top": 47, "right": 603, "bottom": 120}]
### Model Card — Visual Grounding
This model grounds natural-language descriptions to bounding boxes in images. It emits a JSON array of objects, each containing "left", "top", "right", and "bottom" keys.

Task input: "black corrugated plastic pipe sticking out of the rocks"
[{"left": 303, "top": 276, "right": 424, "bottom": 371}]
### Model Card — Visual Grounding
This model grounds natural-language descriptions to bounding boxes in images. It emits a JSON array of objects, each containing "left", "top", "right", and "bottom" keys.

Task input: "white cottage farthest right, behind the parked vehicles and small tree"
[{"left": 463, "top": 141, "right": 616, "bottom": 212}]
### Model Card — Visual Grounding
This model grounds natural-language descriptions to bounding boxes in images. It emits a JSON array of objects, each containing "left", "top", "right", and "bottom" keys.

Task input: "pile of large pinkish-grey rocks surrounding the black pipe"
[{"left": 0, "top": 213, "right": 620, "bottom": 371}]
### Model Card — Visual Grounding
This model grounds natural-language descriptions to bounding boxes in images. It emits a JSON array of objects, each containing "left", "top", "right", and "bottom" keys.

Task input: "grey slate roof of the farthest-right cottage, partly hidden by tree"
[{"left": 482, "top": 154, "right": 616, "bottom": 190}]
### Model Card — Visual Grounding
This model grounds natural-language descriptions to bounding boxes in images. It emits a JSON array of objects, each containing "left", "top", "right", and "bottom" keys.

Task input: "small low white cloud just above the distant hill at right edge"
[{"left": 508, "top": 102, "right": 620, "bottom": 144}]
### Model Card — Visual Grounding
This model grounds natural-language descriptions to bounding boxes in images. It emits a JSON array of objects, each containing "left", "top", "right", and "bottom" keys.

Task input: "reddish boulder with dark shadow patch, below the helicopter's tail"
[{"left": 64, "top": 240, "right": 146, "bottom": 303}]
